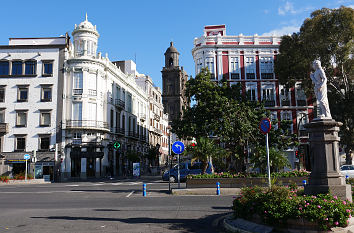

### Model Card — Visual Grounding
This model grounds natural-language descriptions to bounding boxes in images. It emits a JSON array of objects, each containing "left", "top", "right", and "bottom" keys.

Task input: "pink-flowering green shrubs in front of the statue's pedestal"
[{"left": 233, "top": 186, "right": 354, "bottom": 230}]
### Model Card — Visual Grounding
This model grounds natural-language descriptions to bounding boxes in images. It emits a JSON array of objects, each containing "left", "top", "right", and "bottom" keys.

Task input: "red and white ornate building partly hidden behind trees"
[{"left": 192, "top": 25, "right": 314, "bottom": 167}]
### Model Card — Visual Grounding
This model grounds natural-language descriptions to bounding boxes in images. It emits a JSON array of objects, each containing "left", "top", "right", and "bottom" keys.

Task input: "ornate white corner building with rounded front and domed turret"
[{"left": 61, "top": 17, "right": 167, "bottom": 178}]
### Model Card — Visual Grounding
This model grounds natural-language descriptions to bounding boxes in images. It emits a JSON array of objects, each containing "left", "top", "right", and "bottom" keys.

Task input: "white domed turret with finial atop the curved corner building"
[{"left": 72, "top": 13, "right": 100, "bottom": 57}]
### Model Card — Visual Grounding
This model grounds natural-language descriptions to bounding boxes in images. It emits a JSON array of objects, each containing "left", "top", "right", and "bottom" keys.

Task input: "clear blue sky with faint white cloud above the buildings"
[{"left": 0, "top": 0, "right": 354, "bottom": 88}]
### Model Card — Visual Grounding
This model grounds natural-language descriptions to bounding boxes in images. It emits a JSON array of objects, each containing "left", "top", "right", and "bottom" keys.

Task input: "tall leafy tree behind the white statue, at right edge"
[{"left": 275, "top": 7, "right": 354, "bottom": 163}]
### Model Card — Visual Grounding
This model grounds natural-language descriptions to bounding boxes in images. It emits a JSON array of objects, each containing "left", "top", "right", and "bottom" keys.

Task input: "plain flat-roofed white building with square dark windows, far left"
[{"left": 0, "top": 36, "right": 69, "bottom": 179}]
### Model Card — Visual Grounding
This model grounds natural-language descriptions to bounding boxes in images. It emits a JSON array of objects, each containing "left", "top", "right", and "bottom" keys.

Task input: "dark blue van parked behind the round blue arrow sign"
[{"left": 162, "top": 162, "right": 212, "bottom": 182}]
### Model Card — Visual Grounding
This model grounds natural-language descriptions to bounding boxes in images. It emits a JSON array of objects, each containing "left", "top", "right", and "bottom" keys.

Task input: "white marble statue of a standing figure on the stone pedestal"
[{"left": 310, "top": 60, "right": 332, "bottom": 118}]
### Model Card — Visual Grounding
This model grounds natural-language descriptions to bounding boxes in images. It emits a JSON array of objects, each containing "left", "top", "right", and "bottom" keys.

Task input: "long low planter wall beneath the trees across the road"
[{"left": 186, "top": 177, "right": 308, "bottom": 188}]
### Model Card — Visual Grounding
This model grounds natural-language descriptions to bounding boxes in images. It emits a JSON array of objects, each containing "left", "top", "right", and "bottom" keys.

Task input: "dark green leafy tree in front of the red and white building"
[{"left": 172, "top": 69, "right": 291, "bottom": 171}]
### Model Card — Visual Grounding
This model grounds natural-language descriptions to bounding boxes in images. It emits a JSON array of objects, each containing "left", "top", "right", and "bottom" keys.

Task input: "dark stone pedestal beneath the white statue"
[{"left": 305, "top": 119, "right": 352, "bottom": 201}]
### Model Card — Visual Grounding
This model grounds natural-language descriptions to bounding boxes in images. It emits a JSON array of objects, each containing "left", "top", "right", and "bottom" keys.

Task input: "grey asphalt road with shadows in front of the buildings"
[{"left": 0, "top": 177, "right": 233, "bottom": 233}]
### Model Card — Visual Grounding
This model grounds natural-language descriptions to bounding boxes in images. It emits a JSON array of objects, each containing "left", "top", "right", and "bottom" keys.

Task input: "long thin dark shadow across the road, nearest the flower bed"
[{"left": 31, "top": 209, "right": 230, "bottom": 233}]
